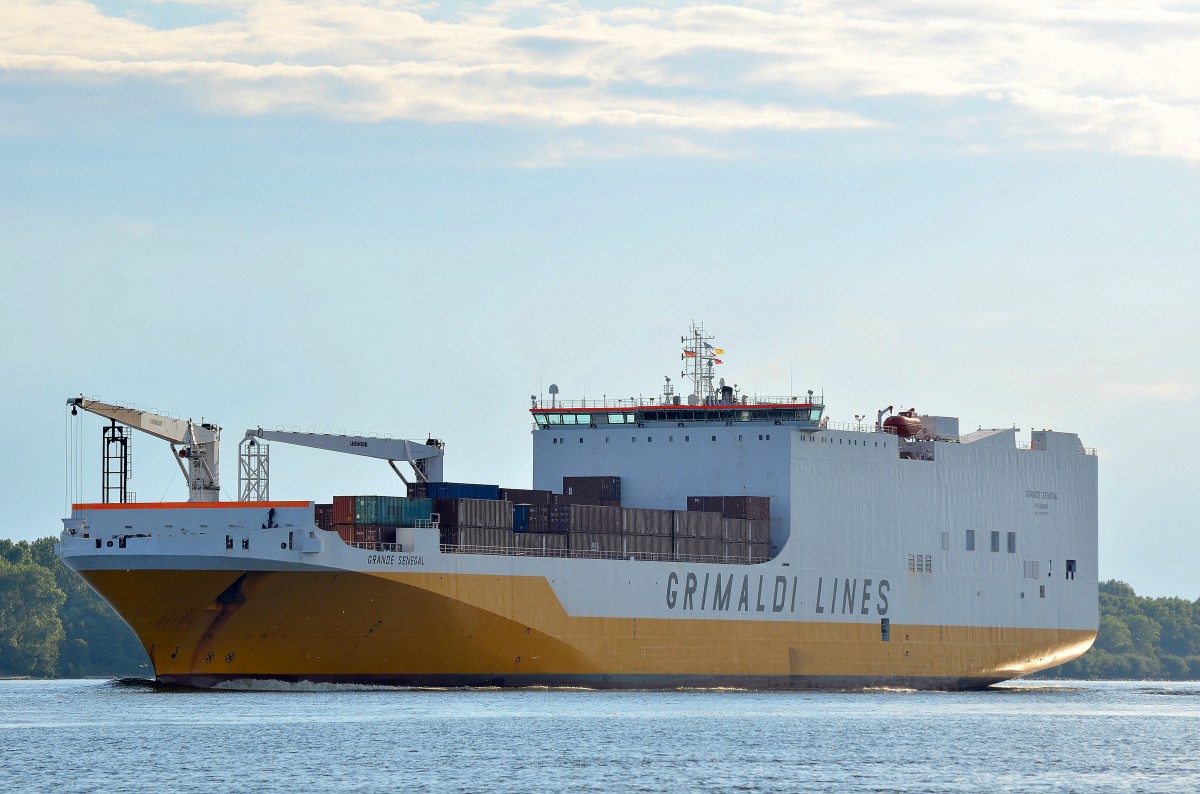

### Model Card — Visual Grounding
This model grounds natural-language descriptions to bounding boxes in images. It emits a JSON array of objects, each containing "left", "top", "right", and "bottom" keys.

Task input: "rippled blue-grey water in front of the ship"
[{"left": 0, "top": 680, "right": 1200, "bottom": 794}]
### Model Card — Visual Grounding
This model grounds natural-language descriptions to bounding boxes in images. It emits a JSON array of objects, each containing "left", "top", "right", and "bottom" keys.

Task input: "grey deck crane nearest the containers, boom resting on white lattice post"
[{"left": 238, "top": 427, "right": 445, "bottom": 501}]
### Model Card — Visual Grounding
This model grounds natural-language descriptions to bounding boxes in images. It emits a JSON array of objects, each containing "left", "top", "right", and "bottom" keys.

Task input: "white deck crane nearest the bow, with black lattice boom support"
[{"left": 67, "top": 396, "right": 221, "bottom": 501}]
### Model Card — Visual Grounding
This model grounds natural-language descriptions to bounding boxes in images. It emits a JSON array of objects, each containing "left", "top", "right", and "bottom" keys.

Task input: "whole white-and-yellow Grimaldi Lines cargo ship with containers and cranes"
[{"left": 58, "top": 325, "right": 1098, "bottom": 690}]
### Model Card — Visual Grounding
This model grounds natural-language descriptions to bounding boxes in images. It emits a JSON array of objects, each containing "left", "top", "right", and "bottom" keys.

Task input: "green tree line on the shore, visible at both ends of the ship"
[{"left": 0, "top": 537, "right": 1200, "bottom": 680}]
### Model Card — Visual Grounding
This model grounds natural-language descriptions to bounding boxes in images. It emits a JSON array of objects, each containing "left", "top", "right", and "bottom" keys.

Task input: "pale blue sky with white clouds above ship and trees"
[{"left": 0, "top": 0, "right": 1200, "bottom": 600}]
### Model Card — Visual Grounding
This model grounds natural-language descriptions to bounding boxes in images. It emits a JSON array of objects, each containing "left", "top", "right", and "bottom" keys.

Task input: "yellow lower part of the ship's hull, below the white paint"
[{"left": 79, "top": 570, "right": 1096, "bottom": 688}]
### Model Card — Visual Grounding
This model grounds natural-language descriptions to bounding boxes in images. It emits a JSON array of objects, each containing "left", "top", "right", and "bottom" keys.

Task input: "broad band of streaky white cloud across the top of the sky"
[{"left": 0, "top": 0, "right": 1200, "bottom": 161}]
